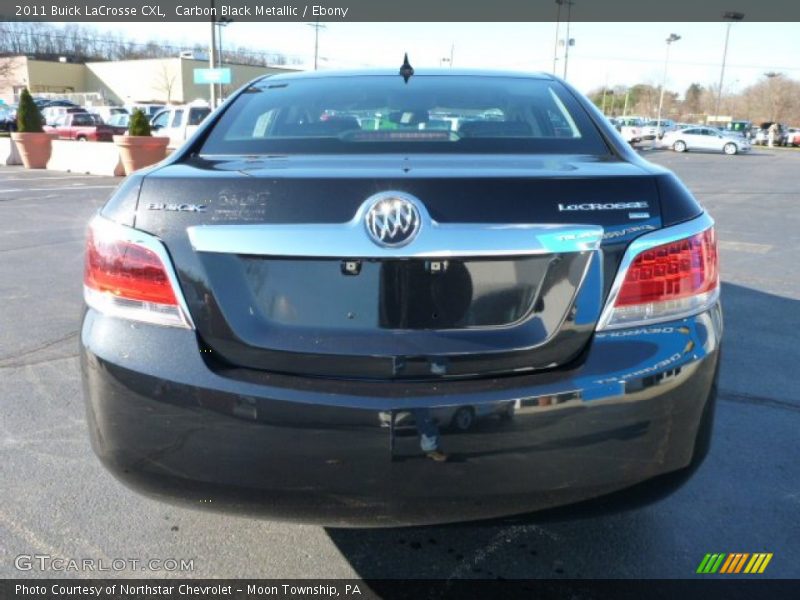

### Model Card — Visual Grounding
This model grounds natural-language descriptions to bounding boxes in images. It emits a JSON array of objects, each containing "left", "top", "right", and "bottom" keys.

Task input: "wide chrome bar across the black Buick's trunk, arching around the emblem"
[{"left": 186, "top": 191, "right": 603, "bottom": 259}]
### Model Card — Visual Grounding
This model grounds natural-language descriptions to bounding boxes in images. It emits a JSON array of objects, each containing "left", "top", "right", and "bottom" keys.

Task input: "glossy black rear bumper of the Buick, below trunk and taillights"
[{"left": 81, "top": 305, "right": 722, "bottom": 526}]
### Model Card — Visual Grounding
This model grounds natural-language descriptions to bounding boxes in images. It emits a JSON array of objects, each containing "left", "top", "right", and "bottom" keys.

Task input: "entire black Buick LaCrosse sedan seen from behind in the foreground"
[{"left": 80, "top": 64, "right": 722, "bottom": 526}]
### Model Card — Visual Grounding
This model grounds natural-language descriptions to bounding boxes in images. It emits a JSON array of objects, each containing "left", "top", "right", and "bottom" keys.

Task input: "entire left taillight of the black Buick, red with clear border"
[{"left": 83, "top": 216, "right": 191, "bottom": 328}]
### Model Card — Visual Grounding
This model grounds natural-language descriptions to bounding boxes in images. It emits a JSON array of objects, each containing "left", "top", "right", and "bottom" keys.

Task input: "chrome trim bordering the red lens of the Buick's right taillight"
[{"left": 596, "top": 212, "right": 719, "bottom": 331}]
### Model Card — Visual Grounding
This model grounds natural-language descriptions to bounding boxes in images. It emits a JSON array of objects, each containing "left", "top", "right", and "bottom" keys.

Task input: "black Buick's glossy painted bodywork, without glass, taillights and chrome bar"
[{"left": 81, "top": 68, "right": 722, "bottom": 526}]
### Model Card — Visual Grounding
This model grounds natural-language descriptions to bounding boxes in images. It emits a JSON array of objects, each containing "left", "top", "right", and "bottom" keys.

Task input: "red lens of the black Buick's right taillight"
[{"left": 614, "top": 227, "right": 719, "bottom": 306}]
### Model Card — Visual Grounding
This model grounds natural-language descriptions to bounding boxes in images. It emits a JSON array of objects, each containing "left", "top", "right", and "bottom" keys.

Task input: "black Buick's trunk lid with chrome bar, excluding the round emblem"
[{"left": 136, "top": 156, "right": 660, "bottom": 379}]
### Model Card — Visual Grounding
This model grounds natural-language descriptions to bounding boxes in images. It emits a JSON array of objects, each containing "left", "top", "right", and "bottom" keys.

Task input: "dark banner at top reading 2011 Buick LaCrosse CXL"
[{"left": 0, "top": 0, "right": 800, "bottom": 22}]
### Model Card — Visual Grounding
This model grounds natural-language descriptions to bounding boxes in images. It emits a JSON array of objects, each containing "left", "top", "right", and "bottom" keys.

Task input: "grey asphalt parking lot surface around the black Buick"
[{"left": 0, "top": 149, "right": 800, "bottom": 579}]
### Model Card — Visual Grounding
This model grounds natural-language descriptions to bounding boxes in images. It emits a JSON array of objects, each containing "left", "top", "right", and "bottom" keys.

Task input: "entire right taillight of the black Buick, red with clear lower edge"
[{"left": 598, "top": 215, "right": 719, "bottom": 330}]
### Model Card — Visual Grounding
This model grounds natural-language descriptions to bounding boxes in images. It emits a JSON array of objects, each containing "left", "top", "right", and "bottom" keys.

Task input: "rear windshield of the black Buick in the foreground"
[{"left": 201, "top": 75, "right": 608, "bottom": 155}]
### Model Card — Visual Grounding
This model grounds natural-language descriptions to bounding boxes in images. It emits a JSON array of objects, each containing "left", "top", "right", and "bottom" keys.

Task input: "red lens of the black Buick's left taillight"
[{"left": 83, "top": 229, "right": 177, "bottom": 306}]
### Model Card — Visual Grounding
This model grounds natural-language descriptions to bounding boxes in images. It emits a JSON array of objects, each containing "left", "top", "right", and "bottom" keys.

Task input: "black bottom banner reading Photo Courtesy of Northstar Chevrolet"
[{"left": 0, "top": 577, "right": 800, "bottom": 600}]
